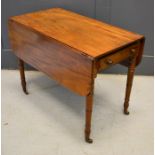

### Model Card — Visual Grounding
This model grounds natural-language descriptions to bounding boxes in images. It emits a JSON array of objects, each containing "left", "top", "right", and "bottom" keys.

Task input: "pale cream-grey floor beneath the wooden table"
[{"left": 2, "top": 70, "right": 153, "bottom": 155}]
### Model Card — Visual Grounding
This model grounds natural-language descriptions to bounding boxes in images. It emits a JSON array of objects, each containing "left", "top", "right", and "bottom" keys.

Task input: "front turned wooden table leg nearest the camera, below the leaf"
[{"left": 85, "top": 86, "right": 93, "bottom": 143}]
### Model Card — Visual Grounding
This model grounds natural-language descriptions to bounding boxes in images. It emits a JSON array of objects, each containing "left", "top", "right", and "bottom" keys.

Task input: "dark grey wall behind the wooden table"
[{"left": 1, "top": 0, "right": 154, "bottom": 75}]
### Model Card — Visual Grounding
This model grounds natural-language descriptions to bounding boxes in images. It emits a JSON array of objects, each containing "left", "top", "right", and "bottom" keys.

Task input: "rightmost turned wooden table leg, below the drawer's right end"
[{"left": 124, "top": 55, "right": 136, "bottom": 115}]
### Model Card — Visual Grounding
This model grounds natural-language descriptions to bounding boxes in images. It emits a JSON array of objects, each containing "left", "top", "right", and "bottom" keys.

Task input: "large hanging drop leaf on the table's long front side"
[{"left": 9, "top": 21, "right": 93, "bottom": 95}]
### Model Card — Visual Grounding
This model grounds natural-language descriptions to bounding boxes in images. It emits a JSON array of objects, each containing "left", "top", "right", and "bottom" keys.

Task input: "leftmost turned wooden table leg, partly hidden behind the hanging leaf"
[{"left": 19, "top": 59, "right": 28, "bottom": 94}]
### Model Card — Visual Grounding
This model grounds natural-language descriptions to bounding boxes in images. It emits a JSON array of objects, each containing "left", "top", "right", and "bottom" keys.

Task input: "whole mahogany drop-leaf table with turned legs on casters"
[{"left": 9, "top": 8, "right": 145, "bottom": 143}]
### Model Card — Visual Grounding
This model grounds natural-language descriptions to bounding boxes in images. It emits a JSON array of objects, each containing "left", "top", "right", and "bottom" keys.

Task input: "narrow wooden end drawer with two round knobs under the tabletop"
[{"left": 97, "top": 44, "right": 139, "bottom": 71}]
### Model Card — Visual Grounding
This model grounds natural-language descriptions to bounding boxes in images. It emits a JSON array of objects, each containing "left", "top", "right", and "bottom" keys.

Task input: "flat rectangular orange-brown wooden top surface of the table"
[{"left": 11, "top": 8, "right": 143, "bottom": 58}]
